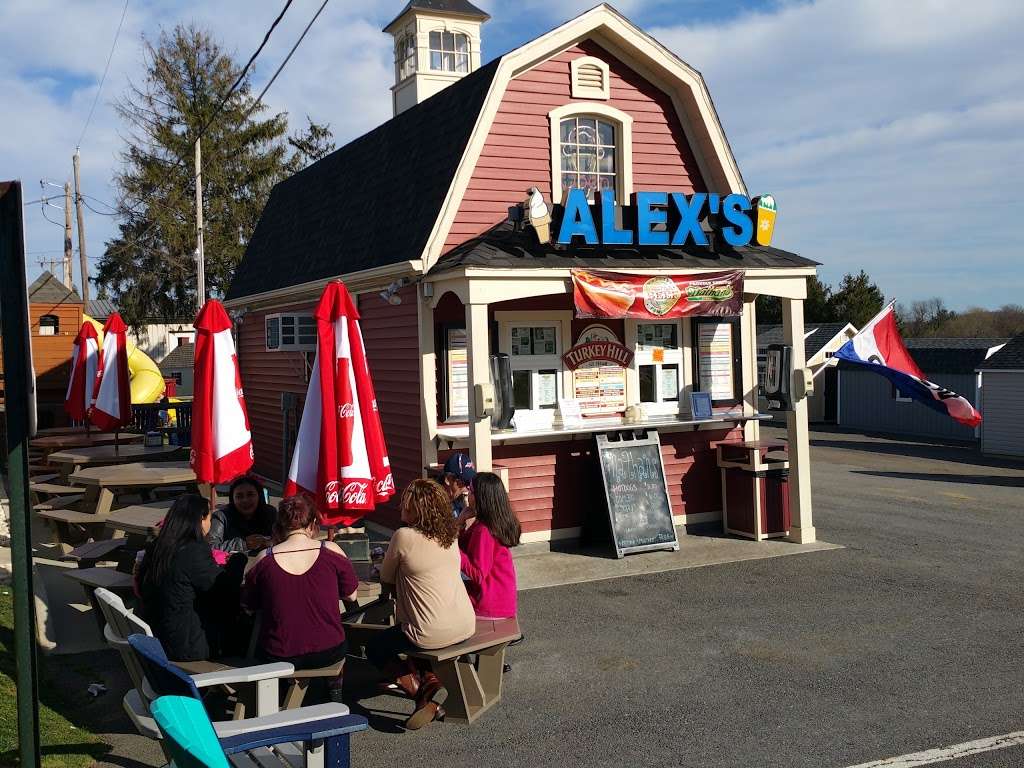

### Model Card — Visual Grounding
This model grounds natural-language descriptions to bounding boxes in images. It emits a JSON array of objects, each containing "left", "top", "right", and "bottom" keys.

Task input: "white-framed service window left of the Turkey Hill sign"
[{"left": 506, "top": 321, "right": 562, "bottom": 421}]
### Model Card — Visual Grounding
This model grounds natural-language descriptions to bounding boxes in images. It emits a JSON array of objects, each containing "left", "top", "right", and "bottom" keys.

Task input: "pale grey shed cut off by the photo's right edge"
[{"left": 977, "top": 334, "right": 1024, "bottom": 458}]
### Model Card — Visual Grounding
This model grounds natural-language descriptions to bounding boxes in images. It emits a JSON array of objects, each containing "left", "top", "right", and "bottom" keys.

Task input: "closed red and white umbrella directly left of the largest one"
[{"left": 189, "top": 299, "right": 253, "bottom": 483}]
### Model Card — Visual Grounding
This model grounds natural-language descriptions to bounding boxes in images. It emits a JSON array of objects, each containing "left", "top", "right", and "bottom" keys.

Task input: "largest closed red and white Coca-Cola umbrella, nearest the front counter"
[{"left": 285, "top": 281, "right": 394, "bottom": 525}]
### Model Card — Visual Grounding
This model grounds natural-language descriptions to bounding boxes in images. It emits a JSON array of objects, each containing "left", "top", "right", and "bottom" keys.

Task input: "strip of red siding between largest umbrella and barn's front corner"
[{"left": 358, "top": 286, "right": 423, "bottom": 528}]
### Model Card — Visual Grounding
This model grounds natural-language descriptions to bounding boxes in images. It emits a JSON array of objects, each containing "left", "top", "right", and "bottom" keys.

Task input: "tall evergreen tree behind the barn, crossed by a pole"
[{"left": 96, "top": 26, "right": 333, "bottom": 326}]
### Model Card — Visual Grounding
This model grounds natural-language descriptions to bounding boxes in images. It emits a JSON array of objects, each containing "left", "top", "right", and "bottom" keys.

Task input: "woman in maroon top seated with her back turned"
[{"left": 242, "top": 496, "right": 359, "bottom": 684}]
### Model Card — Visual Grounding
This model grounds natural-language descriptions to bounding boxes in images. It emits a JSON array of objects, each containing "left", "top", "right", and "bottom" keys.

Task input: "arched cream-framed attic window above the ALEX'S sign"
[{"left": 548, "top": 103, "right": 633, "bottom": 202}]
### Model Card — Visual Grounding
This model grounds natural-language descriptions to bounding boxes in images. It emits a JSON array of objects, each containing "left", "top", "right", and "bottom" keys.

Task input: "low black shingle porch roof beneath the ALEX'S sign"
[{"left": 430, "top": 220, "right": 818, "bottom": 272}]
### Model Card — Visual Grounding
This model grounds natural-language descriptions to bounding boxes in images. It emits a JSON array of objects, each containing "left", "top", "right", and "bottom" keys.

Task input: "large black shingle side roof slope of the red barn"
[{"left": 227, "top": 57, "right": 501, "bottom": 299}]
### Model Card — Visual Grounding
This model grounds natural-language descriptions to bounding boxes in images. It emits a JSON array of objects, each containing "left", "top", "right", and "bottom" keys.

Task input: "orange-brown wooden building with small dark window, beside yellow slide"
[{"left": 0, "top": 271, "right": 82, "bottom": 428}]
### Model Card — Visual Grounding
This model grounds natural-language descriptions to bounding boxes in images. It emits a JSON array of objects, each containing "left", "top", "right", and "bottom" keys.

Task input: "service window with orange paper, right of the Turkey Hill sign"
[{"left": 634, "top": 321, "right": 684, "bottom": 414}]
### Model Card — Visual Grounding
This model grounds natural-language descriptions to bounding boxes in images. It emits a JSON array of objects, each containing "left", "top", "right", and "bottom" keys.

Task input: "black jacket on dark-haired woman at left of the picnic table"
[{"left": 140, "top": 542, "right": 246, "bottom": 662}]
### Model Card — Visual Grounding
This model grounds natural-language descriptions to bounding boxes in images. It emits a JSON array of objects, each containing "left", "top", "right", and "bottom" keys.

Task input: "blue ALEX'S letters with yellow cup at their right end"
[{"left": 555, "top": 188, "right": 776, "bottom": 247}]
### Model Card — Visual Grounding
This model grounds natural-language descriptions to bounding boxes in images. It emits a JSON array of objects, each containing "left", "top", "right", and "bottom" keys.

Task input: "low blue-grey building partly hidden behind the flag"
[{"left": 839, "top": 339, "right": 1007, "bottom": 441}]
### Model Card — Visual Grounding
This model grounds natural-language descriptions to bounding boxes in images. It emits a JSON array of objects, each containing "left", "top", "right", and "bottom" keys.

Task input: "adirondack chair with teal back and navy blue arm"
[{"left": 153, "top": 696, "right": 367, "bottom": 768}]
